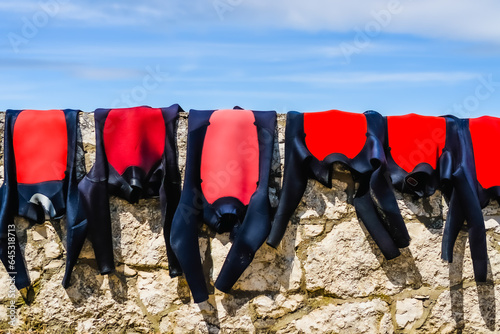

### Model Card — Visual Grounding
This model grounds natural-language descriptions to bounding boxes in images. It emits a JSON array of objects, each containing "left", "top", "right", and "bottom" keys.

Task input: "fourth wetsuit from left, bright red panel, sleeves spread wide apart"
[{"left": 267, "top": 110, "right": 410, "bottom": 259}]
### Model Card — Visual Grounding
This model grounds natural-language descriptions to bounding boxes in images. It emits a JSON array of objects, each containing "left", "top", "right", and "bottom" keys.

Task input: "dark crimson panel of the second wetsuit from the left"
[{"left": 103, "top": 107, "right": 165, "bottom": 175}]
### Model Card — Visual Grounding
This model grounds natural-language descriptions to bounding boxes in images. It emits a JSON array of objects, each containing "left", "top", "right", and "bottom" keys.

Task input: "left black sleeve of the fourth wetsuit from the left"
[{"left": 267, "top": 112, "right": 311, "bottom": 248}]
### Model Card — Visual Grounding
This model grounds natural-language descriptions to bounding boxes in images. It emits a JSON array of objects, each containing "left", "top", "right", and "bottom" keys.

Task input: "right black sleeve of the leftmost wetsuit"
[{"left": 62, "top": 110, "right": 88, "bottom": 288}]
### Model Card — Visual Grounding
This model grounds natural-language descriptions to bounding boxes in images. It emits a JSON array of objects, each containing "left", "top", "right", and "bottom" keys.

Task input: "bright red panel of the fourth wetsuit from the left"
[{"left": 304, "top": 110, "right": 367, "bottom": 160}]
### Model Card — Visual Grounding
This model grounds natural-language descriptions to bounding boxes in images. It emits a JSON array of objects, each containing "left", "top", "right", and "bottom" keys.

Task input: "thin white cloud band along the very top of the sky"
[{"left": 0, "top": 0, "right": 500, "bottom": 43}]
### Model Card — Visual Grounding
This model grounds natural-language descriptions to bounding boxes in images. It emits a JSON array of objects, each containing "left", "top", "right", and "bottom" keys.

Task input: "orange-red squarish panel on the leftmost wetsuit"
[{"left": 13, "top": 110, "right": 68, "bottom": 184}]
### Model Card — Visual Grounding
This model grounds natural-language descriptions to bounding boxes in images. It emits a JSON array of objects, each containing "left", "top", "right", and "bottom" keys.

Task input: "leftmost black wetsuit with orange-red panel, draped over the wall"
[{"left": 0, "top": 109, "right": 86, "bottom": 289}]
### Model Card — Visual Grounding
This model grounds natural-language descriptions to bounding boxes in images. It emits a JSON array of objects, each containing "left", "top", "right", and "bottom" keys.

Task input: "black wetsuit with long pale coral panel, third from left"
[{"left": 170, "top": 109, "right": 276, "bottom": 303}]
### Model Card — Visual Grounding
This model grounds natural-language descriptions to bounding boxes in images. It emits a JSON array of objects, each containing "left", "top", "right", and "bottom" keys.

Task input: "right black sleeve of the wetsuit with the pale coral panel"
[{"left": 215, "top": 113, "right": 278, "bottom": 293}]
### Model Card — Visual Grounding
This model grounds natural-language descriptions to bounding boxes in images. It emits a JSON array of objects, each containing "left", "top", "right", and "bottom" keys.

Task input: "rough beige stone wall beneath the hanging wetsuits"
[{"left": 0, "top": 114, "right": 500, "bottom": 334}]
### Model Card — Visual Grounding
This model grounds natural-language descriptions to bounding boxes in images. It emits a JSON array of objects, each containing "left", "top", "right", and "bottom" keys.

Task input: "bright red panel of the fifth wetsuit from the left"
[{"left": 387, "top": 114, "right": 446, "bottom": 173}]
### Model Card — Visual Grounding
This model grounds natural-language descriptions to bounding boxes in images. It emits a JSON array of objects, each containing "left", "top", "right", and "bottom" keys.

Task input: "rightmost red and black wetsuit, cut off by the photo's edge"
[{"left": 441, "top": 116, "right": 494, "bottom": 282}]
